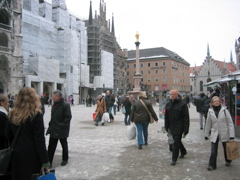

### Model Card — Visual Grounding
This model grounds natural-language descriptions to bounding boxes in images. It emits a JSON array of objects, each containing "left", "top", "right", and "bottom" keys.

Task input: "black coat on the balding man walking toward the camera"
[{"left": 165, "top": 98, "right": 189, "bottom": 135}]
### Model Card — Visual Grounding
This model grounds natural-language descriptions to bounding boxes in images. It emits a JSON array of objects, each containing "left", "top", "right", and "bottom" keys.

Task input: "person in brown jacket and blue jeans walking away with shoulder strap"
[{"left": 130, "top": 91, "right": 158, "bottom": 149}]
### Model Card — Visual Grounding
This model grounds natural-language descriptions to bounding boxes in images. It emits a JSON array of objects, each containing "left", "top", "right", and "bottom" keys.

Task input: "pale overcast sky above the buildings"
[{"left": 66, "top": 0, "right": 240, "bottom": 66}]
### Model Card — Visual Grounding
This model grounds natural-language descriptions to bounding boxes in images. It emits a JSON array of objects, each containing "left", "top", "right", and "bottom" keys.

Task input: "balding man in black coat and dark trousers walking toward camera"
[{"left": 165, "top": 89, "right": 189, "bottom": 166}]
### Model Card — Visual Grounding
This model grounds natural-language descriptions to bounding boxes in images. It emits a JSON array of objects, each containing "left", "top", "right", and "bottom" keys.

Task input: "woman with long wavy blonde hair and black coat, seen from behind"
[{"left": 7, "top": 87, "right": 50, "bottom": 180}]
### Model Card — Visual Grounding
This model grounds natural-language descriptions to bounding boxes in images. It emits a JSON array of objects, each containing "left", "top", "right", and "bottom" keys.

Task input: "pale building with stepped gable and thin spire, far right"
[{"left": 190, "top": 46, "right": 237, "bottom": 95}]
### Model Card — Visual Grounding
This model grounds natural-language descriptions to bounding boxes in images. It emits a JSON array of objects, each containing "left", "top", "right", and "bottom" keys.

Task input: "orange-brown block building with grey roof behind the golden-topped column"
[{"left": 127, "top": 47, "right": 190, "bottom": 95}]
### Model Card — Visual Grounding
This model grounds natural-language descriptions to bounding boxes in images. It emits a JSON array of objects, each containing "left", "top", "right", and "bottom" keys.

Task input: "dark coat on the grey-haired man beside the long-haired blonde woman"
[{"left": 47, "top": 98, "right": 72, "bottom": 139}]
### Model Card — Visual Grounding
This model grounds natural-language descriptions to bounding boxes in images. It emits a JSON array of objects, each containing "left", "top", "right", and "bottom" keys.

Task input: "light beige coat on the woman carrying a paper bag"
[{"left": 205, "top": 107, "right": 235, "bottom": 143}]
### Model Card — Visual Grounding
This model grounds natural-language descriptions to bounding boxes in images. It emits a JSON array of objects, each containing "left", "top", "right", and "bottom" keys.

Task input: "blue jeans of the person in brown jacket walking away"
[{"left": 135, "top": 122, "right": 149, "bottom": 145}]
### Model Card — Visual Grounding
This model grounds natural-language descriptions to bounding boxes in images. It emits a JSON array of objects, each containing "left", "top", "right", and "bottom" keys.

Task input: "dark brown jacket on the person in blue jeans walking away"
[{"left": 130, "top": 99, "right": 158, "bottom": 122}]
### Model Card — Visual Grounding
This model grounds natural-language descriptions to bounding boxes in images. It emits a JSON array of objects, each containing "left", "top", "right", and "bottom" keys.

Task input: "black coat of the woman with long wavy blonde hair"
[{"left": 7, "top": 113, "right": 49, "bottom": 180}]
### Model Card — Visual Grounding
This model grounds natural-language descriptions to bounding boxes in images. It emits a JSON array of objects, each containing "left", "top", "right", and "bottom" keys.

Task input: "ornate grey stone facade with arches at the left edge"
[{"left": 0, "top": 0, "right": 24, "bottom": 94}]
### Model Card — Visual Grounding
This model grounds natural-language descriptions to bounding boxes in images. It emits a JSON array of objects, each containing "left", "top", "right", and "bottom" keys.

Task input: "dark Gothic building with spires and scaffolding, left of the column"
[{"left": 86, "top": 0, "right": 127, "bottom": 96}]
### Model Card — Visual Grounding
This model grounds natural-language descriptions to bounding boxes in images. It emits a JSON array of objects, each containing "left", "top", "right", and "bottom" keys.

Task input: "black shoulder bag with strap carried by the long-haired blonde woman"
[{"left": 0, "top": 126, "right": 21, "bottom": 175}]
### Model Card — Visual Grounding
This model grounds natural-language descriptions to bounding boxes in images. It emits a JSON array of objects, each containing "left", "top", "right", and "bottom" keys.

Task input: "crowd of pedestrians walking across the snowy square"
[{"left": 0, "top": 87, "right": 235, "bottom": 180}]
